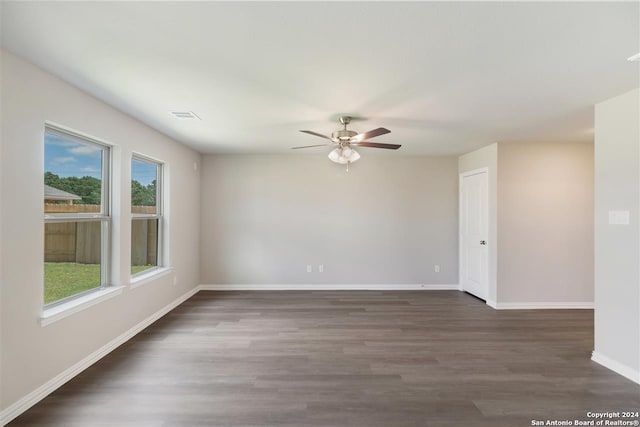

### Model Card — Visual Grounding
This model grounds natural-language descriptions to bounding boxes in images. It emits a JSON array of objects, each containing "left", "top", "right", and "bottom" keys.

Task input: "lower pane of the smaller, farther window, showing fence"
[{"left": 131, "top": 219, "right": 159, "bottom": 274}]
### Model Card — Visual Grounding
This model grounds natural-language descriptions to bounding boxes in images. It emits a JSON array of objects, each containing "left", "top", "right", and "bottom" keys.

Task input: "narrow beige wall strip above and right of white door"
[{"left": 458, "top": 143, "right": 498, "bottom": 306}]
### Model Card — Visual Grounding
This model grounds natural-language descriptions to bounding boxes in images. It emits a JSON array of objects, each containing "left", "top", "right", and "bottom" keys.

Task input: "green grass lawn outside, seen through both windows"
[{"left": 44, "top": 262, "right": 155, "bottom": 304}]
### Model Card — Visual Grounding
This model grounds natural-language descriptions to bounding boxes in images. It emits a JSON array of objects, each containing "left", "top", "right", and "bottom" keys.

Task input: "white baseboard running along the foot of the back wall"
[{"left": 200, "top": 284, "right": 460, "bottom": 291}]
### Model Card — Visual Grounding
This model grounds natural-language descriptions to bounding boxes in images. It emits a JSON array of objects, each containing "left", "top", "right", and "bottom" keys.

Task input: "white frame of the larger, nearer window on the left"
[{"left": 42, "top": 123, "right": 113, "bottom": 310}]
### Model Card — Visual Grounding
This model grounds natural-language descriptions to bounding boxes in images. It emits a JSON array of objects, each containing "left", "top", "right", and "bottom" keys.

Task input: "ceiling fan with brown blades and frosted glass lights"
[{"left": 292, "top": 116, "right": 401, "bottom": 172}]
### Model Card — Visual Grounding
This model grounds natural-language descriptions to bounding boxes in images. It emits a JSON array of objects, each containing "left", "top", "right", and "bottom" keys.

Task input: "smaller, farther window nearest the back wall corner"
[{"left": 131, "top": 155, "right": 163, "bottom": 275}]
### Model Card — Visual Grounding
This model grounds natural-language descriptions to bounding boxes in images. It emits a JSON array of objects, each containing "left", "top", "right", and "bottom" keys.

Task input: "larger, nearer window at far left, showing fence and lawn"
[{"left": 44, "top": 126, "right": 111, "bottom": 306}]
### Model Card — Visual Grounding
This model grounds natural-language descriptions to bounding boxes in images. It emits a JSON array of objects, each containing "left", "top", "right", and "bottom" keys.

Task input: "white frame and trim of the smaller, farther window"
[{"left": 129, "top": 152, "right": 164, "bottom": 280}]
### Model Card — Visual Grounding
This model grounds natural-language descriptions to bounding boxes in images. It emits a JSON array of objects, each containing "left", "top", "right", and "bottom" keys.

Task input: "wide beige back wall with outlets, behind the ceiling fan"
[{"left": 201, "top": 155, "right": 458, "bottom": 285}]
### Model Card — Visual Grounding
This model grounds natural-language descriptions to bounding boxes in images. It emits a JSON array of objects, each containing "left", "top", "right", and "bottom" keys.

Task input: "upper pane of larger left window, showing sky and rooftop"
[{"left": 44, "top": 129, "right": 106, "bottom": 214}]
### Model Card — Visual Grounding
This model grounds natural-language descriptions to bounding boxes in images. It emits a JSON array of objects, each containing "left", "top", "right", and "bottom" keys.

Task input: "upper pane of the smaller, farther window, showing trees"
[{"left": 131, "top": 159, "right": 158, "bottom": 214}]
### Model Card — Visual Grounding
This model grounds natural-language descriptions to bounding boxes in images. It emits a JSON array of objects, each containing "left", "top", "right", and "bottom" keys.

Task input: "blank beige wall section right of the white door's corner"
[{"left": 498, "top": 143, "right": 594, "bottom": 305}]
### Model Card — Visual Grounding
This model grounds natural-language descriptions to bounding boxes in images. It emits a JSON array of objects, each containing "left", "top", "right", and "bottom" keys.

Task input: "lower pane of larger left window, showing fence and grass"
[{"left": 44, "top": 221, "right": 102, "bottom": 304}]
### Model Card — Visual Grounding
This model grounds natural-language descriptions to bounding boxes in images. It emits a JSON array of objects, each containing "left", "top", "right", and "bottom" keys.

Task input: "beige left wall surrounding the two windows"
[{"left": 0, "top": 52, "right": 200, "bottom": 409}]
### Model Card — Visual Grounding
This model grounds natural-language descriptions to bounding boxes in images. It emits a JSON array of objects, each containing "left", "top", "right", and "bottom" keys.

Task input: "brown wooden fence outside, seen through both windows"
[{"left": 44, "top": 204, "right": 158, "bottom": 265}]
